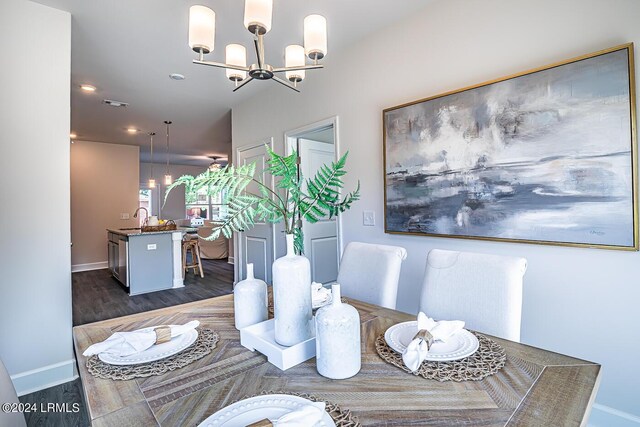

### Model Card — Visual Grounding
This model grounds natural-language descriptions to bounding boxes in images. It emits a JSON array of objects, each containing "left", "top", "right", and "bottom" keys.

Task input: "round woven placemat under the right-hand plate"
[{"left": 376, "top": 332, "right": 507, "bottom": 382}]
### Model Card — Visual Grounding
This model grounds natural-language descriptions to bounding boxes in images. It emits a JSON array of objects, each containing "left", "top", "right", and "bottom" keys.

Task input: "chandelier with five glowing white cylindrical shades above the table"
[{"left": 189, "top": 0, "right": 327, "bottom": 92}]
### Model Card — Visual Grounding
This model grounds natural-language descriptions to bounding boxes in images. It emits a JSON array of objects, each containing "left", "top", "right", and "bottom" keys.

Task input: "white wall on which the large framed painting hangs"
[{"left": 233, "top": 0, "right": 640, "bottom": 426}]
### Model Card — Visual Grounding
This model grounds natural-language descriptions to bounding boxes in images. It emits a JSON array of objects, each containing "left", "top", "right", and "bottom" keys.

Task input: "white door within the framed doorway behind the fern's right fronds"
[{"left": 298, "top": 138, "right": 338, "bottom": 283}]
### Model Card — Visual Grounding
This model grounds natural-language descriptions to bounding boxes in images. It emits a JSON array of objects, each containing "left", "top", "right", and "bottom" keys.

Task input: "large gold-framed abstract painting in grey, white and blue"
[{"left": 383, "top": 44, "right": 638, "bottom": 250}]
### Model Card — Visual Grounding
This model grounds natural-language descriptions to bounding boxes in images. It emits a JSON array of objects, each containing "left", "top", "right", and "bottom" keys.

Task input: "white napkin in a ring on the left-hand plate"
[{"left": 82, "top": 320, "right": 200, "bottom": 356}]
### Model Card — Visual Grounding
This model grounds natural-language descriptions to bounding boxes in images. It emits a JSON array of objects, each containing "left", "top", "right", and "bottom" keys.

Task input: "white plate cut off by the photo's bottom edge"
[{"left": 198, "top": 394, "right": 336, "bottom": 427}]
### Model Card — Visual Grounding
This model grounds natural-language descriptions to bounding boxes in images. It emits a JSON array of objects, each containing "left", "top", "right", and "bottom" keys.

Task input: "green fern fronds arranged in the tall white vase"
[{"left": 165, "top": 146, "right": 360, "bottom": 253}]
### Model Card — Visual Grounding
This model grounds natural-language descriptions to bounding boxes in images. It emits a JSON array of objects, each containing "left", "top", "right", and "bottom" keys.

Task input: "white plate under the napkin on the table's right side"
[{"left": 384, "top": 320, "right": 480, "bottom": 362}]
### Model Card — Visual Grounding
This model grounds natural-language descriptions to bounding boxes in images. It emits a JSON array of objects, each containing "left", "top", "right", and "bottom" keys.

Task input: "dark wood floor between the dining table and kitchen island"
[{"left": 73, "top": 260, "right": 233, "bottom": 326}]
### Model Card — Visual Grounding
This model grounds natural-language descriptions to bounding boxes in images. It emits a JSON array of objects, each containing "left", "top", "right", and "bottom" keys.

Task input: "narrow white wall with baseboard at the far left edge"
[{"left": 0, "top": 0, "right": 75, "bottom": 393}]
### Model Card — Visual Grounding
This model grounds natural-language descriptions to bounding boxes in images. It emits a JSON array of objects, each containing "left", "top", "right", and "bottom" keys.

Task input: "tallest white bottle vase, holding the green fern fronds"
[{"left": 272, "top": 234, "right": 313, "bottom": 346}]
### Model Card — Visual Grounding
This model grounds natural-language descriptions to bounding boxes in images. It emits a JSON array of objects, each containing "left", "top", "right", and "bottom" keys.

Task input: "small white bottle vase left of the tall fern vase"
[{"left": 233, "top": 264, "right": 268, "bottom": 329}]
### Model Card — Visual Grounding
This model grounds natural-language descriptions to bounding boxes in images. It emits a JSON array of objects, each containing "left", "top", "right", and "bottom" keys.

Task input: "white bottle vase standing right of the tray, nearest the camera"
[{"left": 316, "top": 284, "right": 362, "bottom": 380}]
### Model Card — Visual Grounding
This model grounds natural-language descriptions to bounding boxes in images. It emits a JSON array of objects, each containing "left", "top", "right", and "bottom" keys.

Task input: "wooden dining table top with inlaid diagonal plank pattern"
[{"left": 73, "top": 295, "right": 600, "bottom": 427}]
